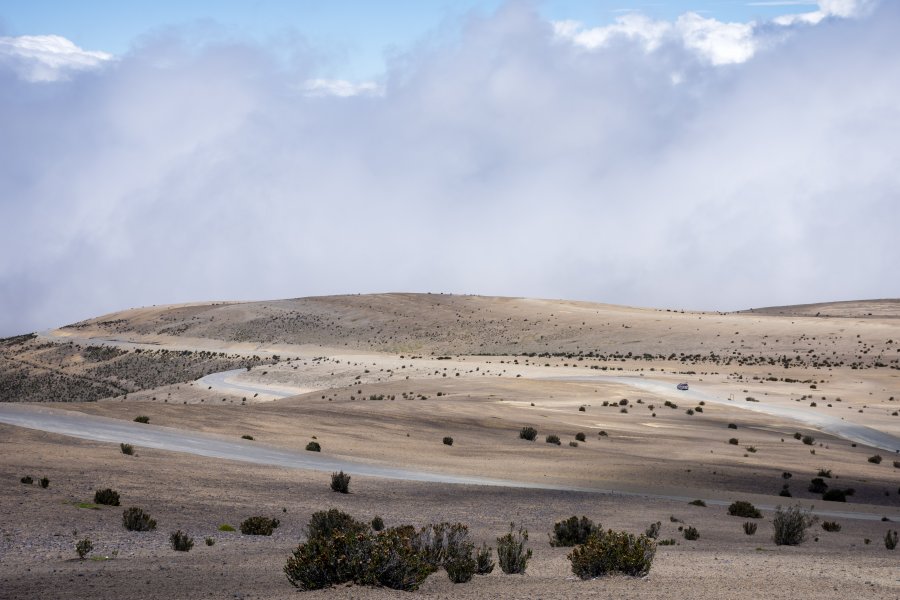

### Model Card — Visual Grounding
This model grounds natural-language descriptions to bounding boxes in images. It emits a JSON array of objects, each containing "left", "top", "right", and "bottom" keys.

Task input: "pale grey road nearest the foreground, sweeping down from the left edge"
[{"left": 0, "top": 402, "right": 900, "bottom": 521}]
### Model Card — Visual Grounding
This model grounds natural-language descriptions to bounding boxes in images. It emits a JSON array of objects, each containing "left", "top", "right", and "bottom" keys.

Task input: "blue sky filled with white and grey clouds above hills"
[{"left": 0, "top": 0, "right": 900, "bottom": 336}]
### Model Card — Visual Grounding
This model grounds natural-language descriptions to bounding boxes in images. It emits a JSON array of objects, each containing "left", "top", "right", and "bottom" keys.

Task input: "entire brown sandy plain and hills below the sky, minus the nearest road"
[{"left": 0, "top": 295, "right": 900, "bottom": 598}]
